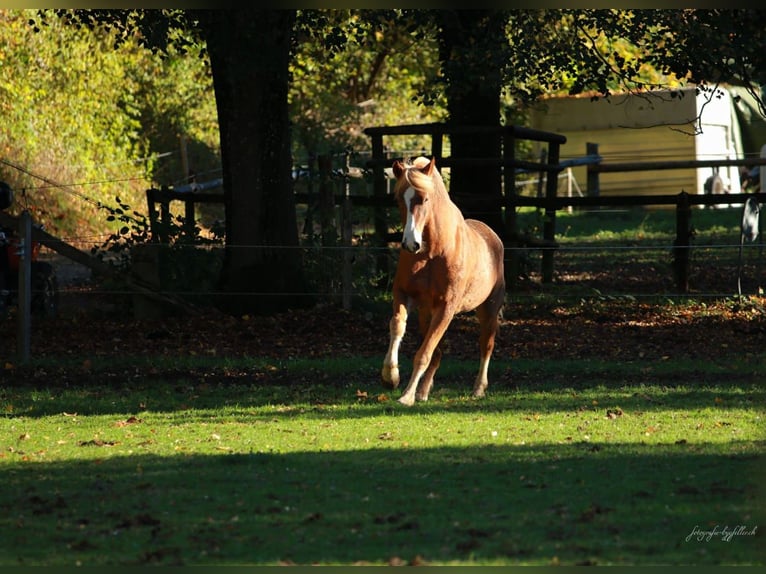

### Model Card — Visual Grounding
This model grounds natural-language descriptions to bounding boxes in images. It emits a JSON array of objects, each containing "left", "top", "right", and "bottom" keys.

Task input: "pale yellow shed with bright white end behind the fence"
[{"left": 530, "top": 89, "right": 741, "bottom": 200}]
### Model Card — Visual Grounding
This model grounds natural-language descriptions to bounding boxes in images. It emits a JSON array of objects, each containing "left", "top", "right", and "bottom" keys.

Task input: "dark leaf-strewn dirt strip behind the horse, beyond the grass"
[{"left": 0, "top": 254, "right": 766, "bottom": 374}]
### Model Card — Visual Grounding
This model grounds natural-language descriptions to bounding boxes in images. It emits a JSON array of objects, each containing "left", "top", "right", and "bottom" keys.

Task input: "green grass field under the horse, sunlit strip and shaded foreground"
[{"left": 0, "top": 356, "right": 766, "bottom": 566}]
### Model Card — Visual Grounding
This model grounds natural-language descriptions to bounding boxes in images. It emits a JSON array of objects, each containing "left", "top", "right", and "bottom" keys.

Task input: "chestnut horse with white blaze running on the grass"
[{"left": 381, "top": 157, "right": 505, "bottom": 406}]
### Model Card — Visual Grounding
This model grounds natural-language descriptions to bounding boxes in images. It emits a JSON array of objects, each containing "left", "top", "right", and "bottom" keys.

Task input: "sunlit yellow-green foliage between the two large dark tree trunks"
[{"left": 289, "top": 10, "right": 445, "bottom": 162}]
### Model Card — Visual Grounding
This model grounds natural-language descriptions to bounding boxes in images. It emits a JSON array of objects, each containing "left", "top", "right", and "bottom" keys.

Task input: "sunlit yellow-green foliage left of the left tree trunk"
[{"left": 0, "top": 10, "right": 220, "bottom": 244}]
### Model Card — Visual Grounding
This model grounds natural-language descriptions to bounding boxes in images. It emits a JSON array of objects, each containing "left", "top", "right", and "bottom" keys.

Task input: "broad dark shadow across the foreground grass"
[{"left": 0, "top": 442, "right": 766, "bottom": 566}]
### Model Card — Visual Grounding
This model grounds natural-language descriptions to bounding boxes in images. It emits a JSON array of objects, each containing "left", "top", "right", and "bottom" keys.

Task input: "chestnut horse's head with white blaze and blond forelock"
[{"left": 393, "top": 157, "right": 438, "bottom": 253}]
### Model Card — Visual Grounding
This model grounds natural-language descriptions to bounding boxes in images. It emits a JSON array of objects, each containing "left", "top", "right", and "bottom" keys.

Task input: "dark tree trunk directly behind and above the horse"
[{"left": 438, "top": 10, "right": 507, "bottom": 237}]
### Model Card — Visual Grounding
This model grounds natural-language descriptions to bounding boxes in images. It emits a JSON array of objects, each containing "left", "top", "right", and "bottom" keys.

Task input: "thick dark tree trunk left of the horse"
[{"left": 200, "top": 10, "right": 316, "bottom": 314}]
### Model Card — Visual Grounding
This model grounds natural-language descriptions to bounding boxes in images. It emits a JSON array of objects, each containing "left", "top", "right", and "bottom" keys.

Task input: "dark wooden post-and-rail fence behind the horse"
[{"left": 142, "top": 123, "right": 766, "bottom": 296}]
